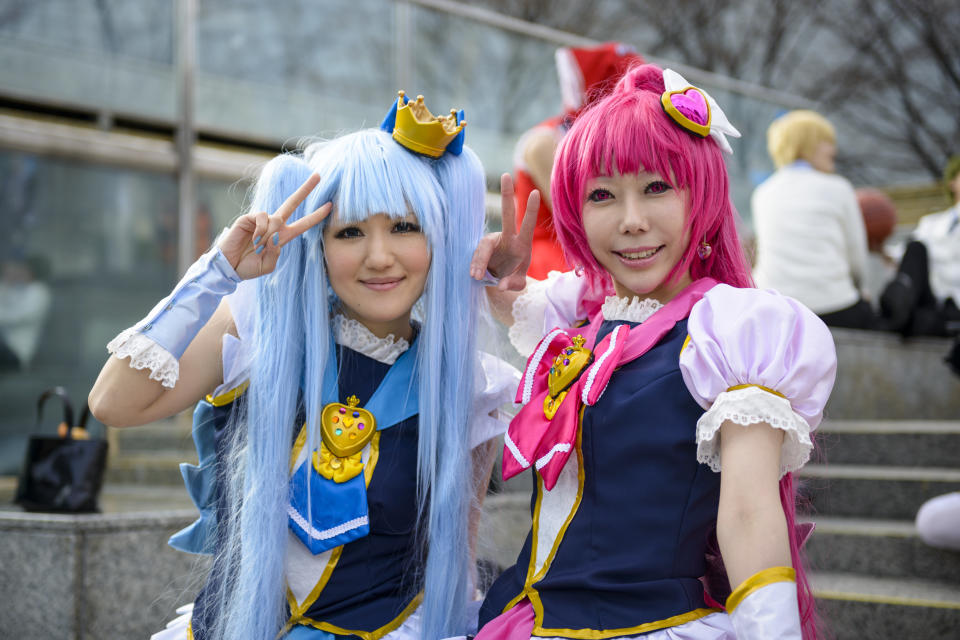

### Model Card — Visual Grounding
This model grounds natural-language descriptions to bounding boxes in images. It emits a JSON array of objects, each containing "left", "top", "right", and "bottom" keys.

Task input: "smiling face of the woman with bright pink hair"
[{"left": 583, "top": 172, "right": 691, "bottom": 303}]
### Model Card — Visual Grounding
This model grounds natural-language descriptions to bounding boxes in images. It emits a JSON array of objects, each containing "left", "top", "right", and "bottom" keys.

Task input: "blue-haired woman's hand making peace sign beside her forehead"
[{"left": 217, "top": 174, "right": 333, "bottom": 280}]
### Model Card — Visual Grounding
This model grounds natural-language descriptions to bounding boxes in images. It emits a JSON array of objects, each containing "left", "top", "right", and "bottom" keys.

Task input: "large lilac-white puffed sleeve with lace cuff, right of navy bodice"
[{"left": 680, "top": 284, "right": 837, "bottom": 475}]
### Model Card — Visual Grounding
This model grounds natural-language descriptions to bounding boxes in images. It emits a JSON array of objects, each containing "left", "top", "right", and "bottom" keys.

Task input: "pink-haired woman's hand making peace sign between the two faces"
[{"left": 470, "top": 173, "right": 540, "bottom": 291}]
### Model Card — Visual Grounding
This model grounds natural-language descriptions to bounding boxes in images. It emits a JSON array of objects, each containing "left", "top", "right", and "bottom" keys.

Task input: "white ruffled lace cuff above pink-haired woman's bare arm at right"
[{"left": 697, "top": 387, "right": 813, "bottom": 477}]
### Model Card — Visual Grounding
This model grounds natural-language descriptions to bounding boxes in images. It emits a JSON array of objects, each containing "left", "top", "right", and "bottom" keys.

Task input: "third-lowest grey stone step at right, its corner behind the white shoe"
[{"left": 798, "top": 464, "right": 960, "bottom": 520}]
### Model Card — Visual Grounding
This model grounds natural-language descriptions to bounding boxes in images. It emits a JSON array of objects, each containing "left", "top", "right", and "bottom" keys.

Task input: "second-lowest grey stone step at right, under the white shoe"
[{"left": 805, "top": 516, "right": 960, "bottom": 584}]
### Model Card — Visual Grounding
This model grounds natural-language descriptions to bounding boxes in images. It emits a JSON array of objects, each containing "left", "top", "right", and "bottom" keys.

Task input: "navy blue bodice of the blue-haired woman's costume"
[{"left": 192, "top": 347, "right": 423, "bottom": 640}]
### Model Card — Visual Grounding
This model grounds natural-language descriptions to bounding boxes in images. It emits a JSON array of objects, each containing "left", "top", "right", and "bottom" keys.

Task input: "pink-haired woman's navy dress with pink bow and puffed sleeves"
[{"left": 480, "top": 274, "right": 836, "bottom": 640}]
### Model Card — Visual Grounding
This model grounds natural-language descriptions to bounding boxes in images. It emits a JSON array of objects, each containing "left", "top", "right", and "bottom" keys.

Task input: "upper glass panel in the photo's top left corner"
[{"left": 0, "top": 0, "right": 176, "bottom": 121}]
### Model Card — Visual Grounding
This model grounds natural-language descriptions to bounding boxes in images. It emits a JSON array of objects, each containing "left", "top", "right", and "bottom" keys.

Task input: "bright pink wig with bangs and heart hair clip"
[{"left": 550, "top": 64, "right": 753, "bottom": 291}]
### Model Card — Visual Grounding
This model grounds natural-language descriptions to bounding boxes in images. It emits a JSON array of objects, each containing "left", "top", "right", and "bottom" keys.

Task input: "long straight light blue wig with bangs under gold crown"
[{"left": 212, "top": 130, "right": 484, "bottom": 640}]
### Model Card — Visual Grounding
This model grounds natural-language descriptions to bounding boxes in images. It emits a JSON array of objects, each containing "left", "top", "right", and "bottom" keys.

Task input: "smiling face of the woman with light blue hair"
[{"left": 323, "top": 213, "right": 430, "bottom": 339}]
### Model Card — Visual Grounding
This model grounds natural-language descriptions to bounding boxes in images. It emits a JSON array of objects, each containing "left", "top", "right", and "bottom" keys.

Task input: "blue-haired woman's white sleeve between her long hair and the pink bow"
[{"left": 469, "top": 351, "right": 520, "bottom": 449}]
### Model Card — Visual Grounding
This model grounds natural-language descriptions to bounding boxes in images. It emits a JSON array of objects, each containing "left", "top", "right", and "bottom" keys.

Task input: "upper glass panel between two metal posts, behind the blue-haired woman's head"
[{"left": 196, "top": 0, "right": 396, "bottom": 141}]
